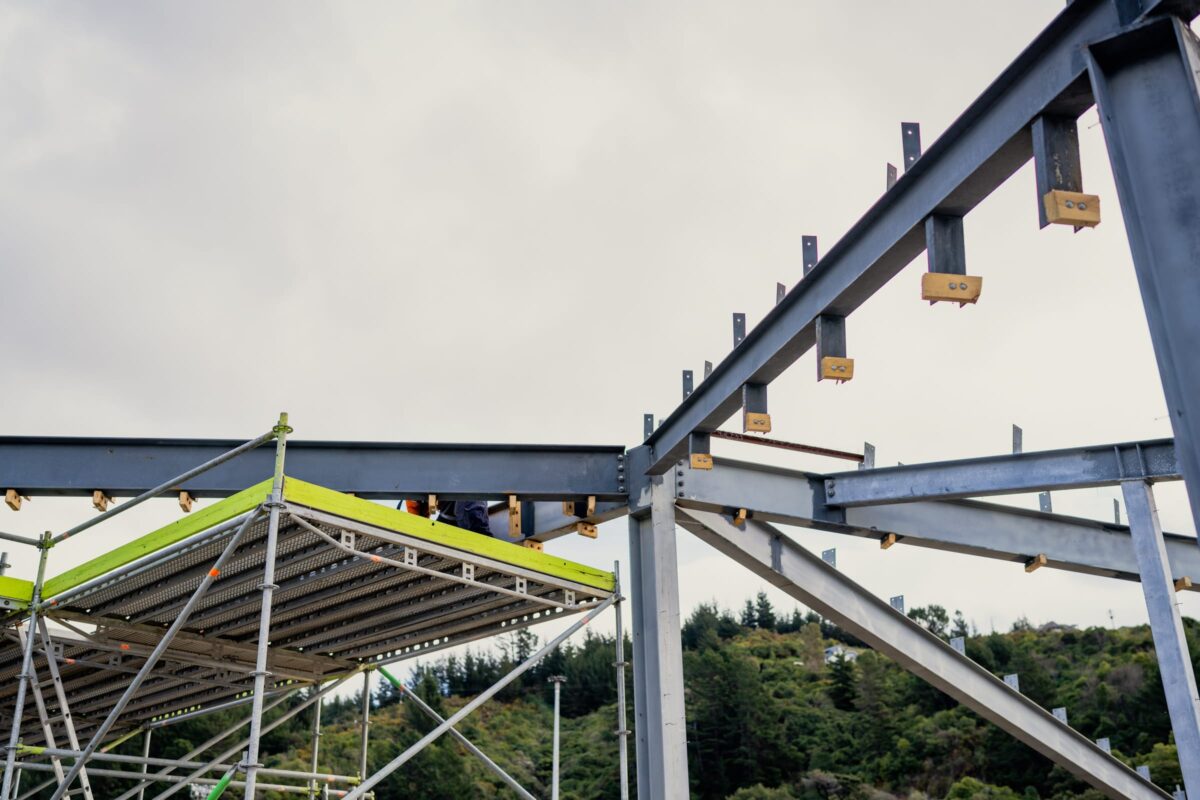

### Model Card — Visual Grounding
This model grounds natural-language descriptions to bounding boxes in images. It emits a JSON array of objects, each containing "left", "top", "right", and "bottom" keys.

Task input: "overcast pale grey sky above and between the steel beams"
[{"left": 0, "top": 0, "right": 1200, "bottom": 681}]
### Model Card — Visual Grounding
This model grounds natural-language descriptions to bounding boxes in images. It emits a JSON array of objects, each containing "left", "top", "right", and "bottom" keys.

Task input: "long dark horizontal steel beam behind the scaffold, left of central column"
[{"left": 0, "top": 437, "right": 625, "bottom": 500}]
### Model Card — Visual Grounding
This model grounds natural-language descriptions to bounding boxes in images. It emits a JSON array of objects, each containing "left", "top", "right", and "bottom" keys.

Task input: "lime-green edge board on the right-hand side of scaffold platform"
[{"left": 283, "top": 477, "right": 617, "bottom": 593}]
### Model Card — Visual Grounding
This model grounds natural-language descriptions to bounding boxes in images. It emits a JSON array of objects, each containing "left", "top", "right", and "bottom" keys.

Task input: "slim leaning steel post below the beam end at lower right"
[{"left": 1121, "top": 481, "right": 1200, "bottom": 798}]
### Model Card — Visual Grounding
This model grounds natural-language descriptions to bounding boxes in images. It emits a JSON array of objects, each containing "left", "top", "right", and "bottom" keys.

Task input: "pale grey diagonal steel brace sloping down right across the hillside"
[{"left": 679, "top": 510, "right": 1169, "bottom": 800}]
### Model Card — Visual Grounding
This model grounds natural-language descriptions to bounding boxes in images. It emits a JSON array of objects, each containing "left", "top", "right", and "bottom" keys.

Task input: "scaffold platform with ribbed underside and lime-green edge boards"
[{"left": 0, "top": 477, "right": 616, "bottom": 745}]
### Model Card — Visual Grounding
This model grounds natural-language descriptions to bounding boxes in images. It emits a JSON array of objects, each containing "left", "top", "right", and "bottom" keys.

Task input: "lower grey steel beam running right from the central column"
[{"left": 676, "top": 458, "right": 1200, "bottom": 590}]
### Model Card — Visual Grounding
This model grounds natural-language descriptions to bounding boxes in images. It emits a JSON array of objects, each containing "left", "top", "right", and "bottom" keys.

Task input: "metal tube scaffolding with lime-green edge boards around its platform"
[{"left": 0, "top": 415, "right": 624, "bottom": 800}]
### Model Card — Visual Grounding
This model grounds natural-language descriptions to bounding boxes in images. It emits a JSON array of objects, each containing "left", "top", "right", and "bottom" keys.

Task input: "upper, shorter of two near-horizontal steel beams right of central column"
[{"left": 824, "top": 438, "right": 1176, "bottom": 507}]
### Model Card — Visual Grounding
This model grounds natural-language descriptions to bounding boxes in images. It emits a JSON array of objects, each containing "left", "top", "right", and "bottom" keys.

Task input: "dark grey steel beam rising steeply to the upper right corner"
[{"left": 647, "top": 1, "right": 1200, "bottom": 474}]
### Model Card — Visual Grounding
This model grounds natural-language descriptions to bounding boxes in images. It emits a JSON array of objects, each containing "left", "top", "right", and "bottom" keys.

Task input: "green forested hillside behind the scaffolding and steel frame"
[{"left": 49, "top": 596, "right": 1200, "bottom": 800}]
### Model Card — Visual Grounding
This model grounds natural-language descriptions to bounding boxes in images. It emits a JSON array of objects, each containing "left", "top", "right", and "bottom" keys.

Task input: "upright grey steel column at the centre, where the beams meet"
[{"left": 629, "top": 476, "right": 688, "bottom": 799}]
